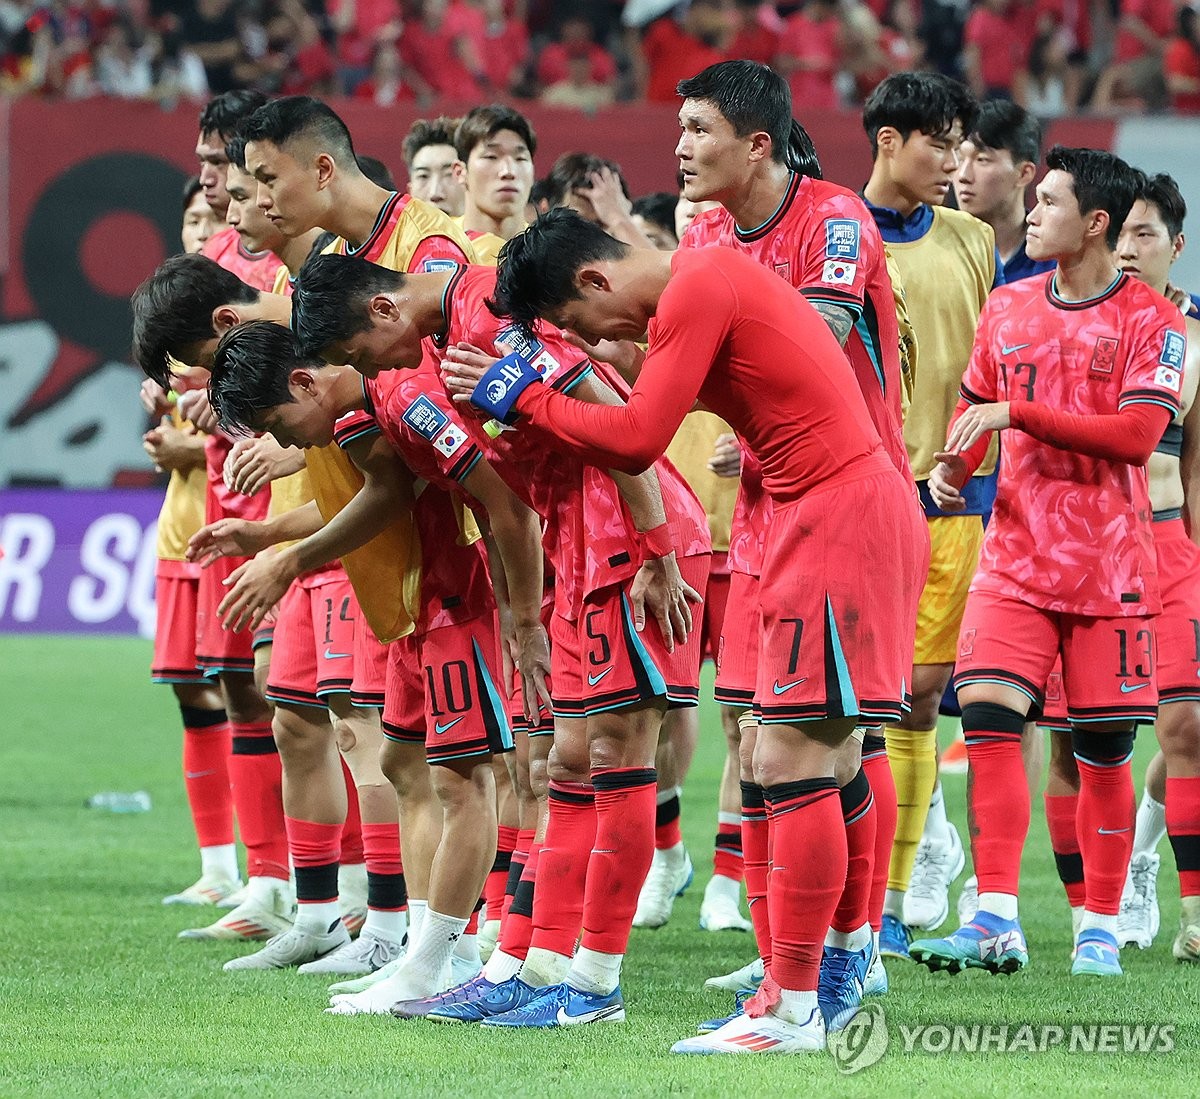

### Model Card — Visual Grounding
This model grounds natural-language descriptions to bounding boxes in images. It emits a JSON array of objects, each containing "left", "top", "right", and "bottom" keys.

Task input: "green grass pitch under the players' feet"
[{"left": 0, "top": 636, "right": 1200, "bottom": 1097}]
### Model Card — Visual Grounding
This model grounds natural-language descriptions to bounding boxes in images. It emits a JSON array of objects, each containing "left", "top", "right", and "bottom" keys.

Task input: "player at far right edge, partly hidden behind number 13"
[{"left": 1046, "top": 175, "right": 1200, "bottom": 961}]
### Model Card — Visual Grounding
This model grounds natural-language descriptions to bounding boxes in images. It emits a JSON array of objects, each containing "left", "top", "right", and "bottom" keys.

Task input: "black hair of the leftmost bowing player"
[{"left": 130, "top": 254, "right": 259, "bottom": 389}]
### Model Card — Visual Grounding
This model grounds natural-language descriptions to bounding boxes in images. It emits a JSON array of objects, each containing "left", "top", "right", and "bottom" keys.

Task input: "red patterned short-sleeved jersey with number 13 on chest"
[{"left": 961, "top": 274, "right": 1187, "bottom": 617}]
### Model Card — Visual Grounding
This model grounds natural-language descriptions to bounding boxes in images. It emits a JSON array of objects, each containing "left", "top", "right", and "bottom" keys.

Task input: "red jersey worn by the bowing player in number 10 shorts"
[{"left": 334, "top": 403, "right": 496, "bottom": 636}]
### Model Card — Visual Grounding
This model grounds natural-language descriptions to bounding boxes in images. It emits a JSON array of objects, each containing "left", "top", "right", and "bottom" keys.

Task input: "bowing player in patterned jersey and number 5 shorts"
[{"left": 280, "top": 256, "right": 709, "bottom": 1026}]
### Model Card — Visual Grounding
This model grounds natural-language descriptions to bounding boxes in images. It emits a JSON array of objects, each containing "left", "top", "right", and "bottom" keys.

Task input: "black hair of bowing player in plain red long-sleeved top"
[{"left": 487, "top": 208, "right": 630, "bottom": 331}]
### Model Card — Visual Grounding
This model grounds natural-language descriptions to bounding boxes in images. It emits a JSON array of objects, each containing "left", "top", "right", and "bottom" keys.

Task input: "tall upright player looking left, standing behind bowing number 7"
[{"left": 676, "top": 61, "right": 911, "bottom": 990}]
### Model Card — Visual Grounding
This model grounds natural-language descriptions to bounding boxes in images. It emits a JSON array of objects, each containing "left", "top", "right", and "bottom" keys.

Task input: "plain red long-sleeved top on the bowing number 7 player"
[{"left": 516, "top": 248, "right": 886, "bottom": 504}]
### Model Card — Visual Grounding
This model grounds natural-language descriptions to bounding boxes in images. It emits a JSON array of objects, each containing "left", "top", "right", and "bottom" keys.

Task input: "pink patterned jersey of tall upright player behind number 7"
[{"left": 679, "top": 174, "right": 912, "bottom": 576}]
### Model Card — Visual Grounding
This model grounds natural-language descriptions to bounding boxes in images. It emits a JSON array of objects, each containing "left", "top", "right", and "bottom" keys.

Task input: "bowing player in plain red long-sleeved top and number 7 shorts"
[{"left": 449, "top": 210, "right": 925, "bottom": 1053}]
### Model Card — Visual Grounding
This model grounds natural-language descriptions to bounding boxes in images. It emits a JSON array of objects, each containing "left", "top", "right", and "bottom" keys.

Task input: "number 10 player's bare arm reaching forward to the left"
[{"left": 217, "top": 434, "right": 414, "bottom": 630}]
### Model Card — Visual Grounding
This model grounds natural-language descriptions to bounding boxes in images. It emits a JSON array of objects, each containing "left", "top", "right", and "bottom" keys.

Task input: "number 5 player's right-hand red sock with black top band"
[{"left": 581, "top": 767, "right": 657, "bottom": 954}]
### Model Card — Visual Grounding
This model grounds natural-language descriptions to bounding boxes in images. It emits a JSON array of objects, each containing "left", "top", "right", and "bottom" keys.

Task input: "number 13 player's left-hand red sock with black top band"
[{"left": 962, "top": 702, "right": 1027, "bottom": 896}]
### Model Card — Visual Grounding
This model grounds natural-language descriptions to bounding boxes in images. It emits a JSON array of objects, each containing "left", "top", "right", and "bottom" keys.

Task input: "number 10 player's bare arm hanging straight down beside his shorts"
[{"left": 461, "top": 460, "right": 550, "bottom": 720}]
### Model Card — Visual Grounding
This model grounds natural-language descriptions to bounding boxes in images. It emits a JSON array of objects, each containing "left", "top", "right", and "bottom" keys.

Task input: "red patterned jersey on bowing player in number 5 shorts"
[{"left": 430, "top": 266, "right": 712, "bottom": 621}]
